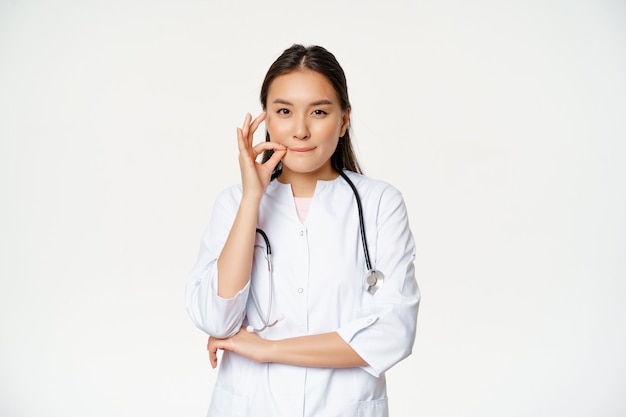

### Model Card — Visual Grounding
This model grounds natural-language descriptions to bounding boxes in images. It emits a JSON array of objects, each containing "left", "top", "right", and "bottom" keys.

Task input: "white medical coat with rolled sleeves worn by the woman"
[{"left": 186, "top": 171, "right": 420, "bottom": 417}]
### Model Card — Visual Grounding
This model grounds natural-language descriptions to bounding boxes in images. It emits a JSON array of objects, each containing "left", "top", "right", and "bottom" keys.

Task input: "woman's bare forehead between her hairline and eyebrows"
[{"left": 267, "top": 70, "right": 339, "bottom": 104}]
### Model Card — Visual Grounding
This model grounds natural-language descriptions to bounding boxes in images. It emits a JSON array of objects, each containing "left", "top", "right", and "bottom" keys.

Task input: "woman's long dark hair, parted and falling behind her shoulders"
[{"left": 260, "top": 44, "right": 362, "bottom": 173}]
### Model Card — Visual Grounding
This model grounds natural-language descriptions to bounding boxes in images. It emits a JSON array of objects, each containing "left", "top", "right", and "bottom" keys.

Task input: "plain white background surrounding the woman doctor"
[{"left": 0, "top": 0, "right": 626, "bottom": 417}]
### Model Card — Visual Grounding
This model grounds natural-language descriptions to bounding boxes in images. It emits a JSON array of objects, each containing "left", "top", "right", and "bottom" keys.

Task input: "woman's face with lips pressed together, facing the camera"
[{"left": 265, "top": 70, "right": 350, "bottom": 182}]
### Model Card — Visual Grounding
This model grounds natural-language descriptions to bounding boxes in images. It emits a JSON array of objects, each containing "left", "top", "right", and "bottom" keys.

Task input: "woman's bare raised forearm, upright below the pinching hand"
[{"left": 217, "top": 198, "right": 259, "bottom": 298}]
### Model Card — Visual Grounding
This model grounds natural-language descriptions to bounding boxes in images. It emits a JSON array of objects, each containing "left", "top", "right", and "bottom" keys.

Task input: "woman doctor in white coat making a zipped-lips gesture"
[{"left": 186, "top": 45, "right": 420, "bottom": 417}]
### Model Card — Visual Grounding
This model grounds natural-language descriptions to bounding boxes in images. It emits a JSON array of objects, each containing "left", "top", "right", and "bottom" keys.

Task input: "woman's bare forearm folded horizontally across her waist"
[{"left": 266, "top": 332, "right": 367, "bottom": 368}]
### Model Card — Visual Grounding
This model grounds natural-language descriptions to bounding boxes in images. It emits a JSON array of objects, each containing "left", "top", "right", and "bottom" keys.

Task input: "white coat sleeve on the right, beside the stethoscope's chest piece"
[{"left": 337, "top": 186, "right": 421, "bottom": 376}]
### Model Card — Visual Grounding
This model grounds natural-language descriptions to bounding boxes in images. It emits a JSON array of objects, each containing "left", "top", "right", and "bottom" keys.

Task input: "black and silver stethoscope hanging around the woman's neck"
[{"left": 246, "top": 171, "right": 385, "bottom": 332}]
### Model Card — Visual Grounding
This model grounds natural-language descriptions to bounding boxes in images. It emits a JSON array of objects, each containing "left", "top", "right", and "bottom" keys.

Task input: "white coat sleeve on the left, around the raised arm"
[{"left": 185, "top": 187, "right": 249, "bottom": 338}]
